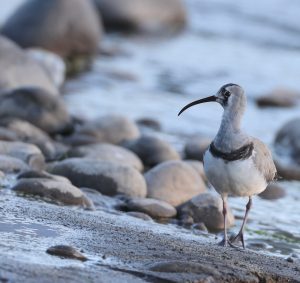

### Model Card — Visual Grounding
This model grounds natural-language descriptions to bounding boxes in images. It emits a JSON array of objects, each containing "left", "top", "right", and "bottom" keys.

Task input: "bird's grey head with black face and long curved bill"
[{"left": 178, "top": 83, "right": 246, "bottom": 116}]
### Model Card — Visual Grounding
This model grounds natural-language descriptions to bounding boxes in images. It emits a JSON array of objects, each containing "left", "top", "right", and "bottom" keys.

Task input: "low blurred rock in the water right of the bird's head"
[{"left": 256, "top": 88, "right": 300, "bottom": 107}]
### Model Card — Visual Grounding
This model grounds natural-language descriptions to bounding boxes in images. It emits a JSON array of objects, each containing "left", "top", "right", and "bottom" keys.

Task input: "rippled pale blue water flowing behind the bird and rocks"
[{"left": 0, "top": 0, "right": 300, "bottom": 255}]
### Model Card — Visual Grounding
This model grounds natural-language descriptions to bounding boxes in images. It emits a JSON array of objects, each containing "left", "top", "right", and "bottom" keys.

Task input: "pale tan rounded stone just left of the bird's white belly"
[{"left": 145, "top": 161, "right": 206, "bottom": 206}]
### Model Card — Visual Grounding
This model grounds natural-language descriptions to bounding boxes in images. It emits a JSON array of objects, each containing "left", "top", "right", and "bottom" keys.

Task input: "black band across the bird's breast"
[{"left": 209, "top": 142, "right": 253, "bottom": 161}]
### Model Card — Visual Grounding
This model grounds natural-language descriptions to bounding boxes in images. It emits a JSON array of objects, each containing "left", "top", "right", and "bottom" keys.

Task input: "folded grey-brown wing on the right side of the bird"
[{"left": 253, "top": 138, "right": 277, "bottom": 183}]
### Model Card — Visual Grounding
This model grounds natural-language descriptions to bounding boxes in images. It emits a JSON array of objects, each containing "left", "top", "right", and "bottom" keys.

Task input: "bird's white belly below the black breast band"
[{"left": 203, "top": 150, "right": 267, "bottom": 196}]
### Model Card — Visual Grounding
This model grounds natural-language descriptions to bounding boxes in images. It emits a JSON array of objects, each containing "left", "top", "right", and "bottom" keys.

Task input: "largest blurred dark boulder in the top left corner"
[{"left": 2, "top": 0, "right": 101, "bottom": 57}]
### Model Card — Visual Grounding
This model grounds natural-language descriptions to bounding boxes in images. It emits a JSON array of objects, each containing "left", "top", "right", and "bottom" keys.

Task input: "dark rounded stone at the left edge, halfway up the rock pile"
[{"left": 0, "top": 87, "right": 72, "bottom": 134}]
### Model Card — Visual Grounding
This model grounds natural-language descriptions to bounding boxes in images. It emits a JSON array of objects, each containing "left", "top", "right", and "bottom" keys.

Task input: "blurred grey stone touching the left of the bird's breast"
[{"left": 184, "top": 137, "right": 211, "bottom": 161}]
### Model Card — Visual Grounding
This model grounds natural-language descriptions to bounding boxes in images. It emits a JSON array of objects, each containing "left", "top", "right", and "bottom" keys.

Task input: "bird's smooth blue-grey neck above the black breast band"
[{"left": 214, "top": 111, "right": 249, "bottom": 152}]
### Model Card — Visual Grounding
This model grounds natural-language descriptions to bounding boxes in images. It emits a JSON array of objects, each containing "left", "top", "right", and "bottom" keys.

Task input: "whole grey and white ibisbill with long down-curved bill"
[{"left": 178, "top": 83, "right": 276, "bottom": 248}]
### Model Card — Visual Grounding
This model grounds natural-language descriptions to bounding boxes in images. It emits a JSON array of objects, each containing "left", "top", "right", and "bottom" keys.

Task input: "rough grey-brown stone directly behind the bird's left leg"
[{"left": 178, "top": 193, "right": 234, "bottom": 231}]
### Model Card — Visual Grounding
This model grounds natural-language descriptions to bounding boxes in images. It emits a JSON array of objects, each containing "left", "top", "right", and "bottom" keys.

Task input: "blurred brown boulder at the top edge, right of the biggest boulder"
[{"left": 95, "top": 0, "right": 186, "bottom": 32}]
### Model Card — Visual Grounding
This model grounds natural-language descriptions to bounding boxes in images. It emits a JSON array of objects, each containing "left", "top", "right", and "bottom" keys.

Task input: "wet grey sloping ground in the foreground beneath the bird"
[{"left": 0, "top": 192, "right": 300, "bottom": 282}]
